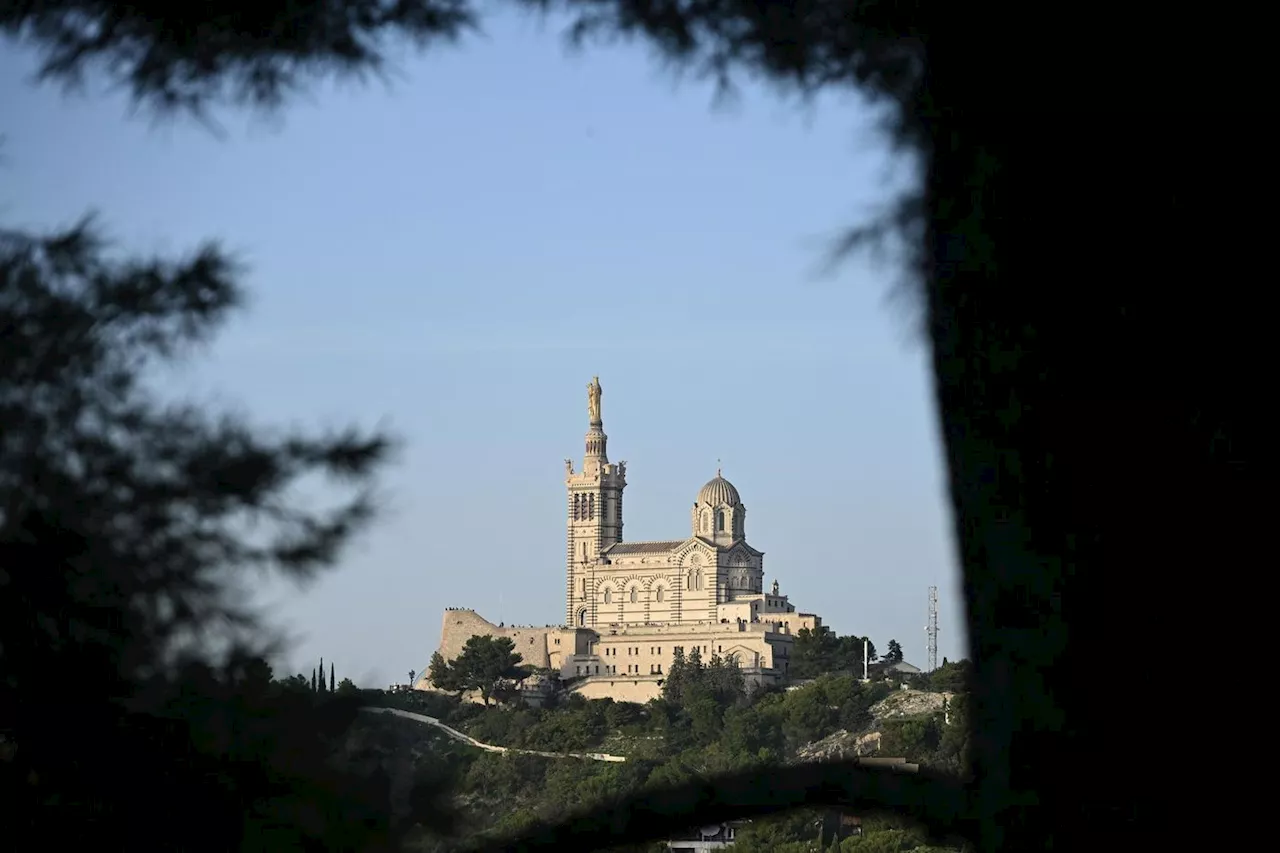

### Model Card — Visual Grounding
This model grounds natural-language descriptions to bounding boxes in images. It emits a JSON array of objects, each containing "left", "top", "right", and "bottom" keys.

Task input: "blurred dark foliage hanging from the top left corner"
[{"left": 0, "top": 0, "right": 472, "bottom": 113}]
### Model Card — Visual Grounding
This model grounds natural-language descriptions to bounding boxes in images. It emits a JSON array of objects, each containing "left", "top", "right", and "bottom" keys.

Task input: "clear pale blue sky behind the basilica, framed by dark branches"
[{"left": 0, "top": 8, "right": 965, "bottom": 685}]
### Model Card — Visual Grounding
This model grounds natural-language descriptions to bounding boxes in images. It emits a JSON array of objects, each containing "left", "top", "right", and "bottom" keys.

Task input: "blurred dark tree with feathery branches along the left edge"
[{"left": 0, "top": 222, "right": 460, "bottom": 849}]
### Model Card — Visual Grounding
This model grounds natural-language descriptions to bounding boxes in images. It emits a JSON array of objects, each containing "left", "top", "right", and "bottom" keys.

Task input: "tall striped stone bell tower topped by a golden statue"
[{"left": 564, "top": 377, "right": 627, "bottom": 628}]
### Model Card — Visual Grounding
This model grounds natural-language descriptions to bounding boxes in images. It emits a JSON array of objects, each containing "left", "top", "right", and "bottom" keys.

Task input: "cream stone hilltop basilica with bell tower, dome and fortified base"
[{"left": 413, "top": 378, "right": 820, "bottom": 702}]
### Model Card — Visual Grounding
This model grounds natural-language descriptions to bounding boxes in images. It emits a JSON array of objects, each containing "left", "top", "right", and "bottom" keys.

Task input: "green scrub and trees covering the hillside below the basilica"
[{"left": 342, "top": 638, "right": 968, "bottom": 853}]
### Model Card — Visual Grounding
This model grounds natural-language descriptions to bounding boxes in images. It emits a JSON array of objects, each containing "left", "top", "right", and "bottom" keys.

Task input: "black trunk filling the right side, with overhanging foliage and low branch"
[{"left": 0, "top": 0, "right": 1249, "bottom": 852}]
